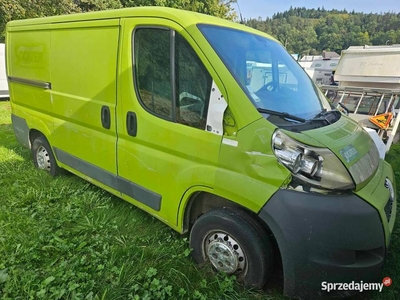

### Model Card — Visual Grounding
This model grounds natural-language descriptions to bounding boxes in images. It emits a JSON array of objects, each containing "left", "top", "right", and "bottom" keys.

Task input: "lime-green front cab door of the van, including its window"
[{"left": 117, "top": 18, "right": 227, "bottom": 227}]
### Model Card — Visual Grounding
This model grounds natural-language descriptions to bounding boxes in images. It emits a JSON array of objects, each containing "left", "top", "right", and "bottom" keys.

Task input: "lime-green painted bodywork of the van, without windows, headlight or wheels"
[{"left": 6, "top": 7, "right": 394, "bottom": 238}]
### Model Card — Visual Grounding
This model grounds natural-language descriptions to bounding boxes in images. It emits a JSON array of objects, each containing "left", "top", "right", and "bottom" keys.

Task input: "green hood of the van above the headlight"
[{"left": 286, "top": 116, "right": 380, "bottom": 190}]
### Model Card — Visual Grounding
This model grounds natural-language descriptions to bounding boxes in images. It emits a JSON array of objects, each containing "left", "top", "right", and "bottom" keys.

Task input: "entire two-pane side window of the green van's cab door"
[{"left": 134, "top": 28, "right": 212, "bottom": 129}]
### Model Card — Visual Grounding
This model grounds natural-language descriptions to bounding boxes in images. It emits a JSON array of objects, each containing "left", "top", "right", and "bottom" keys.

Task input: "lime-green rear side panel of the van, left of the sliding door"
[{"left": 6, "top": 25, "right": 53, "bottom": 146}]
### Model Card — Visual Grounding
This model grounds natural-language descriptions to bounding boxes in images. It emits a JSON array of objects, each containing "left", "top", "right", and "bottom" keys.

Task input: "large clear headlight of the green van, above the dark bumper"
[{"left": 272, "top": 130, "right": 355, "bottom": 190}]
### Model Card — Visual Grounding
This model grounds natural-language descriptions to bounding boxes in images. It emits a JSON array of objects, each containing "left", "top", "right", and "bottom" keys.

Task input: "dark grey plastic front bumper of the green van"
[{"left": 259, "top": 163, "right": 396, "bottom": 299}]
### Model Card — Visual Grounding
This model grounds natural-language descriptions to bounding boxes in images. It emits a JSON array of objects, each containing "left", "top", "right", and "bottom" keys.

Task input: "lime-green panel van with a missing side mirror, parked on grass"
[{"left": 6, "top": 7, "right": 396, "bottom": 298}]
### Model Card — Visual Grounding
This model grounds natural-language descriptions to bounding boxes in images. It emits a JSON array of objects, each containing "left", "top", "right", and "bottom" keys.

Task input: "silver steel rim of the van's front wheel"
[{"left": 204, "top": 231, "right": 246, "bottom": 274}]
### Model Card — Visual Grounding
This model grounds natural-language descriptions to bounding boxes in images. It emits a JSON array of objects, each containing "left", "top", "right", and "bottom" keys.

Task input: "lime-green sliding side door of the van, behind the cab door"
[{"left": 50, "top": 19, "right": 119, "bottom": 176}]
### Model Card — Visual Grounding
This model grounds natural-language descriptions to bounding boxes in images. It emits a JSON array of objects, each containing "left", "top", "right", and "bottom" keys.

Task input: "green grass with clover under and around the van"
[{"left": 0, "top": 102, "right": 400, "bottom": 300}]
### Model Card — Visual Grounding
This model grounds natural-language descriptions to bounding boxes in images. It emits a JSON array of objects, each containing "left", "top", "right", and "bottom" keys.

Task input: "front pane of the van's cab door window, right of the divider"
[{"left": 175, "top": 34, "right": 212, "bottom": 129}]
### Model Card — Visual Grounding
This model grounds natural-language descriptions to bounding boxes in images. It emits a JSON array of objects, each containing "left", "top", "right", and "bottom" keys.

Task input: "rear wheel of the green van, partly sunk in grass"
[{"left": 31, "top": 136, "right": 62, "bottom": 177}]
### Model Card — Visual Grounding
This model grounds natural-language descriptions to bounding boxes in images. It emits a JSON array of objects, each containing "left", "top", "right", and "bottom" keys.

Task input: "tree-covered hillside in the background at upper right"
[{"left": 244, "top": 7, "right": 400, "bottom": 55}]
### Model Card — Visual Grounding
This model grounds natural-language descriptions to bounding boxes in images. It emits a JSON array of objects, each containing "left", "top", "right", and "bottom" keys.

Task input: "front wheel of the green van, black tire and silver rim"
[{"left": 190, "top": 208, "right": 273, "bottom": 289}]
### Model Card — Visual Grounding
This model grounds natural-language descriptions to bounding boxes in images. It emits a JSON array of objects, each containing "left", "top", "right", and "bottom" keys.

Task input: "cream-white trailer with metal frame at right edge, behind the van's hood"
[{"left": 321, "top": 45, "right": 400, "bottom": 157}]
